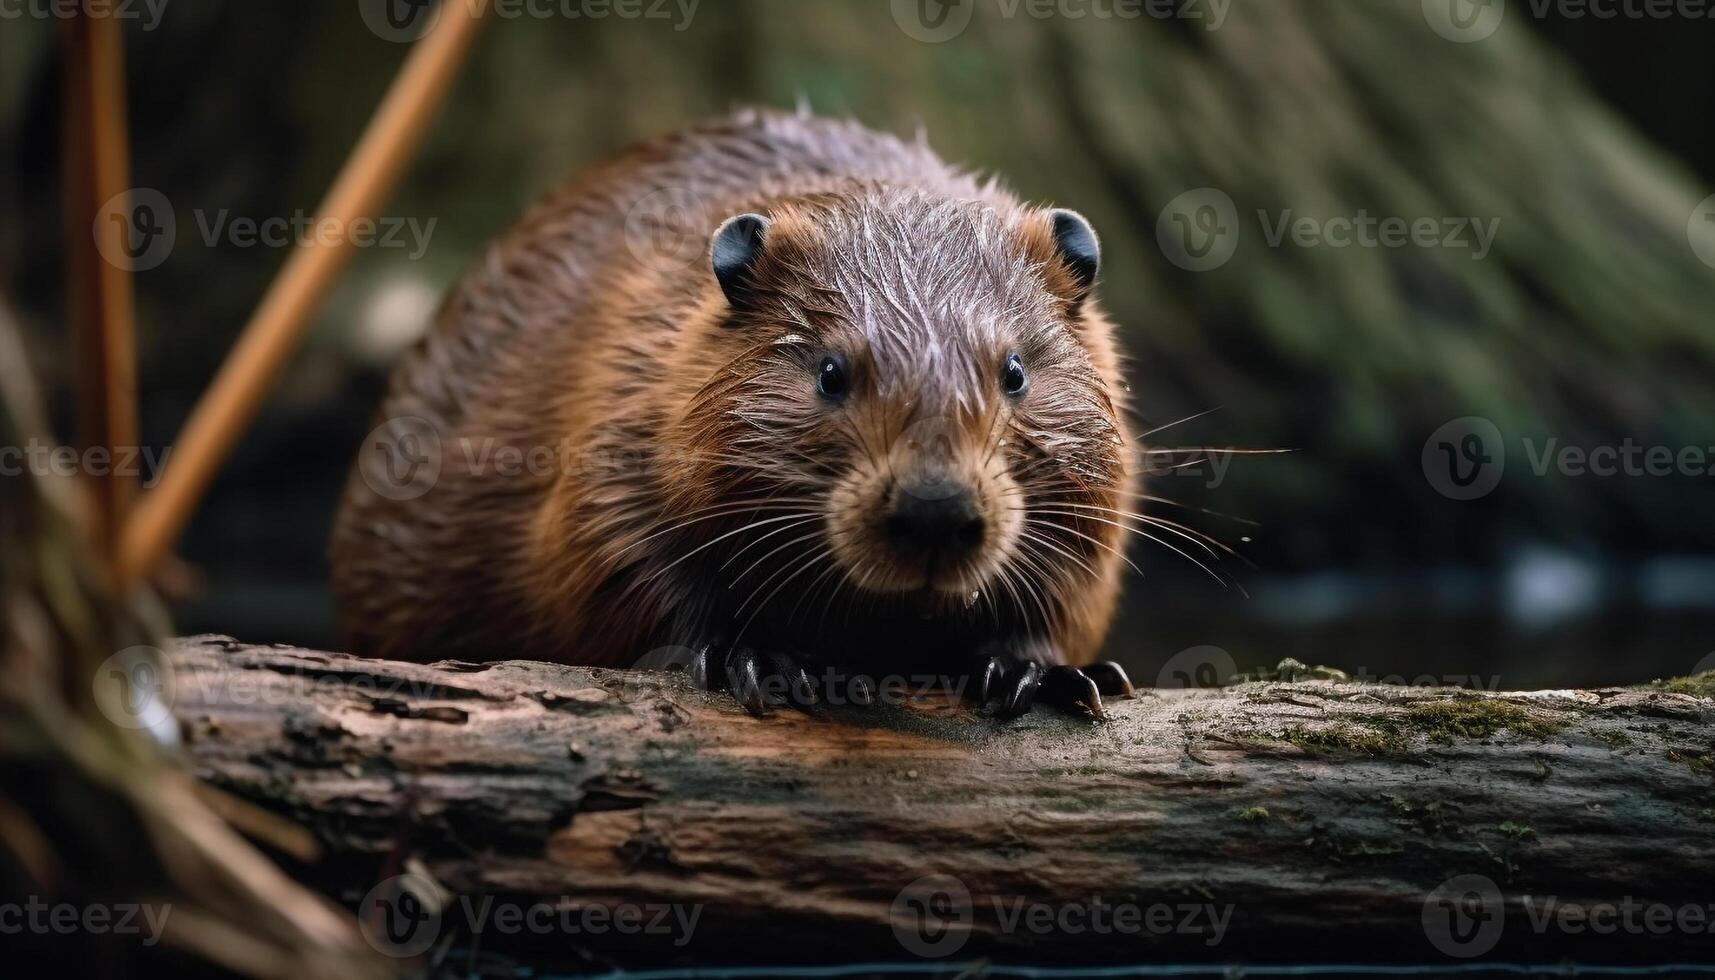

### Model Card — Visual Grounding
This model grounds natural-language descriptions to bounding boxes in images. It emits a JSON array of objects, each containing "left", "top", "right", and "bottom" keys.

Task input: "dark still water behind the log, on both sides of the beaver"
[{"left": 177, "top": 553, "right": 1715, "bottom": 690}]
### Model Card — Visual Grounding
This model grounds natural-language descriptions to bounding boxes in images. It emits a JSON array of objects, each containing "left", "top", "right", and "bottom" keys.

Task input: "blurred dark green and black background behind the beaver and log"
[{"left": 0, "top": 0, "right": 1715, "bottom": 687}]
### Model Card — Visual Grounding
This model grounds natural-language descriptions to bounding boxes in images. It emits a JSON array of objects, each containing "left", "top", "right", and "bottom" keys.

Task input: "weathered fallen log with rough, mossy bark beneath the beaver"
[{"left": 172, "top": 637, "right": 1715, "bottom": 963}]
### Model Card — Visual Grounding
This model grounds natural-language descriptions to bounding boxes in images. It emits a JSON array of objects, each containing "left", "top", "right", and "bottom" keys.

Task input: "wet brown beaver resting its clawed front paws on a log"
[{"left": 331, "top": 110, "right": 1135, "bottom": 716}]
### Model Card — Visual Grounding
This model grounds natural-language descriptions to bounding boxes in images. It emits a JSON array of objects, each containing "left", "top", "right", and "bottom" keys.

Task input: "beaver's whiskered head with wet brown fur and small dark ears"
[{"left": 667, "top": 185, "right": 1125, "bottom": 618}]
